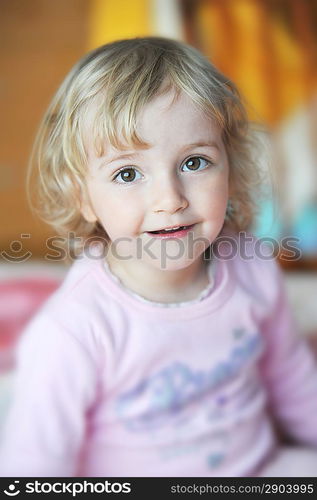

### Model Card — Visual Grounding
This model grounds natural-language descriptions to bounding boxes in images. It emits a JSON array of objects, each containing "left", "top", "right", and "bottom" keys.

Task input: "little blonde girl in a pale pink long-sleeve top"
[{"left": 1, "top": 38, "right": 317, "bottom": 477}]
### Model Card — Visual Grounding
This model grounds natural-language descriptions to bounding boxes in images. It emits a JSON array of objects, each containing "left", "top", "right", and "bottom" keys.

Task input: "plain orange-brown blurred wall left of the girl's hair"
[{"left": 0, "top": 0, "right": 90, "bottom": 257}]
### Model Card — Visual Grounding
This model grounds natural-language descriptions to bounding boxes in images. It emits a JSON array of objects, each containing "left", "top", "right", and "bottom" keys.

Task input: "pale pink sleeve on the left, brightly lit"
[{"left": 0, "top": 315, "right": 96, "bottom": 477}]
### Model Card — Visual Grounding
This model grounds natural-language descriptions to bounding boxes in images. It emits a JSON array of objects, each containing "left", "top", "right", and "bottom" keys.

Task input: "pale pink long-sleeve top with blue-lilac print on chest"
[{"left": 0, "top": 238, "right": 317, "bottom": 477}]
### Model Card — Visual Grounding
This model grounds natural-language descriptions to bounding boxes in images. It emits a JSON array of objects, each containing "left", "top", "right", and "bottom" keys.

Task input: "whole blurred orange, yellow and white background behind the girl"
[{"left": 0, "top": 0, "right": 317, "bottom": 368}]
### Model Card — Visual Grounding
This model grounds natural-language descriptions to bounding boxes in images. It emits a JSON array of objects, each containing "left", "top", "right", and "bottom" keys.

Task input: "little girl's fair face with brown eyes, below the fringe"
[{"left": 82, "top": 92, "right": 229, "bottom": 269}]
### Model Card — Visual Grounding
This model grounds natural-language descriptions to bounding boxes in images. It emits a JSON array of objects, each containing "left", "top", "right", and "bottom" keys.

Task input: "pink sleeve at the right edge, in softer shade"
[{"left": 261, "top": 263, "right": 317, "bottom": 446}]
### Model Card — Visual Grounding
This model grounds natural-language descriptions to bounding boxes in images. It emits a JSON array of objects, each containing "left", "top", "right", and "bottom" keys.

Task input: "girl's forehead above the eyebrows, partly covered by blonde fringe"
[{"left": 83, "top": 89, "right": 222, "bottom": 156}]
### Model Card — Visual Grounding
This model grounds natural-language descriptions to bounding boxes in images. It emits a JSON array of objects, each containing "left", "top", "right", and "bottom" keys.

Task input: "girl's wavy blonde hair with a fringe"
[{"left": 27, "top": 37, "right": 260, "bottom": 252}]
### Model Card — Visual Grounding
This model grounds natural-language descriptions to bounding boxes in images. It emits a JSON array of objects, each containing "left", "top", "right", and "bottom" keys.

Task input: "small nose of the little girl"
[{"left": 152, "top": 177, "right": 189, "bottom": 214}]
